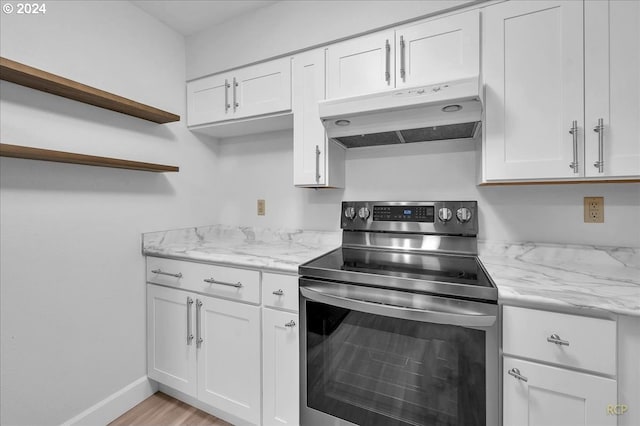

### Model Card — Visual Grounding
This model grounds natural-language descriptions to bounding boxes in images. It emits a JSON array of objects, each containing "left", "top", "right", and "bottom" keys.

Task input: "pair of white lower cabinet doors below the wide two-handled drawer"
[{"left": 147, "top": 284, "right": 260, "bottom": 424}]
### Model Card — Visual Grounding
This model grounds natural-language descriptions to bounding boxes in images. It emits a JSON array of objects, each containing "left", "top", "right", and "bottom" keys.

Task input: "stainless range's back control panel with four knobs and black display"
[{"left": 340, "top": 201, "right": 478, "bottom": 236}]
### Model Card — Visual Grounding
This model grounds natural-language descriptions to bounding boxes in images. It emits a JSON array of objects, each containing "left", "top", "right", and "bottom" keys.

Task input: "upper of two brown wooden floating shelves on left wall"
[{"left": 0, "top": 57, "right": 180, "bottom": 124}]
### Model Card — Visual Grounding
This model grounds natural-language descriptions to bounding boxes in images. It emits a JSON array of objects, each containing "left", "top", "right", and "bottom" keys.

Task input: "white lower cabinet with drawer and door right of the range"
[{"left": 502, "top": 306, "right": 618, "bottom": 426}]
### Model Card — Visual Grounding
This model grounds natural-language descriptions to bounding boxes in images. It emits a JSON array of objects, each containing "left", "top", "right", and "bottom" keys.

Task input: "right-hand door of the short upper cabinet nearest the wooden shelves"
[{"left": 231, "top": 58, "right": 291, "bottom": 118}]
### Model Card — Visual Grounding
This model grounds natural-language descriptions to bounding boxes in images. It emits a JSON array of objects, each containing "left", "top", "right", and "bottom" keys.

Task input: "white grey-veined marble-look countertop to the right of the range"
[{"left": 478, "top": 242, "right": 640, "bottom": 316}]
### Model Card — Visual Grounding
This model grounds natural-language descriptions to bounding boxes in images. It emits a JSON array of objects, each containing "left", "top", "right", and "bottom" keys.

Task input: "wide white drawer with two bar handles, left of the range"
[{"left": 147, "top": 257, "right": 260, "bottom": 304}]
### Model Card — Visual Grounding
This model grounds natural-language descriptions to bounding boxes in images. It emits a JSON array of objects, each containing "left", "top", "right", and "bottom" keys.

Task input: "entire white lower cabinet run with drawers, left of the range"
[{"left": 147, "top": 262, "right": 300, "bottom": 426}]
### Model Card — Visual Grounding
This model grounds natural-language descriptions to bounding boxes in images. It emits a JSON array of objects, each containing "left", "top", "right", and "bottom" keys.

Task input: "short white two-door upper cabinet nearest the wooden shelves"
[{"left": 187, "top": 58, "right": 291, "bottom": 126}]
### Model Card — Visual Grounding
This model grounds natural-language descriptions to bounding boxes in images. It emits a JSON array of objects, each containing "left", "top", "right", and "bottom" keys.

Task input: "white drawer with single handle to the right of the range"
[{"left": 503, "top": 306, "right": 616, "bottom": 375}]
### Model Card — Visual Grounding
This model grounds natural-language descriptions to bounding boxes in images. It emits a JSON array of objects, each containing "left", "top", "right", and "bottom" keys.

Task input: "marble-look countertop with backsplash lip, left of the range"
[{"left": 142, "top": 225, "right": 342, "bottom": 274}]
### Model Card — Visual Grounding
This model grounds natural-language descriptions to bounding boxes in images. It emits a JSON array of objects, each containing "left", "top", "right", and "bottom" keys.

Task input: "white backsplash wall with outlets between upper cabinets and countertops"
[{"left": 217, "top": 131, "right": 640, "bottom": 247}]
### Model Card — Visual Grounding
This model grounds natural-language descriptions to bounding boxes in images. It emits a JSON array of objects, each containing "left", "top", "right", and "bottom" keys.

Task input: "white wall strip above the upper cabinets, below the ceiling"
[{"left": 187, "top": 0, "right": 476, "bottom": 79}]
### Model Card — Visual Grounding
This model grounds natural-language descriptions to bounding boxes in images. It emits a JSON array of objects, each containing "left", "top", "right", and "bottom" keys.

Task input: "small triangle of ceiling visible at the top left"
[{"left": 131, "top": 0, "right": 276, "bottom": 36}]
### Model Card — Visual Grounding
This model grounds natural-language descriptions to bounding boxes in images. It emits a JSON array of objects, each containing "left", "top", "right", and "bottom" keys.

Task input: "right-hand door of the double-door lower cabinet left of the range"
[{"left": 196, "top": 296, "right": 260, "bottom": 424}]
